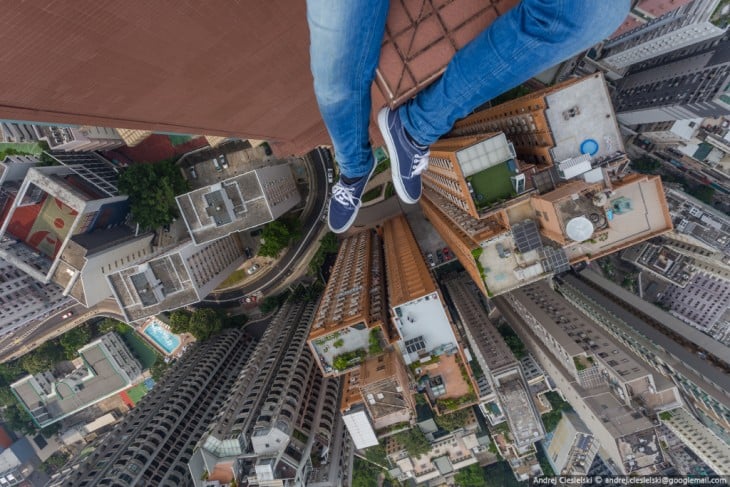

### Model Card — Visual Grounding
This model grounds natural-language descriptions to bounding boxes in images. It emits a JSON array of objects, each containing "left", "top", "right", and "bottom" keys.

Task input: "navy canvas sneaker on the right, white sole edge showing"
[{"left": 378, "top": 107, "right": 429, "bottom": 204}]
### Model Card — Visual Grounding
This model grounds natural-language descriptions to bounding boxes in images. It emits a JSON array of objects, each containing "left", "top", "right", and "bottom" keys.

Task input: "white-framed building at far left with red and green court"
[{"left": 0, "top": 153, "right": 152, "bottom": 306}]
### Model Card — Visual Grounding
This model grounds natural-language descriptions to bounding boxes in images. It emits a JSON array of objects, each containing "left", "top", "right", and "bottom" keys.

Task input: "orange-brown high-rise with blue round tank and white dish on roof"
[{"left": 421, "top": 74, "right": 672, "bottom": 295}]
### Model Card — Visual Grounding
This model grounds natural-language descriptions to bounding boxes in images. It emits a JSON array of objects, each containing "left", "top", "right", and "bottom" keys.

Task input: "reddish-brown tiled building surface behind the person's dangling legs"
[{"left": 0, "top": 0, "right": 632, "bottom": 155}]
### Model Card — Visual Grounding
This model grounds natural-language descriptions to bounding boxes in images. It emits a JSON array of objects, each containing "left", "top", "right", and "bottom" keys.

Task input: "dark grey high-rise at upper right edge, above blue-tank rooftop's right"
[{"left": 613, "top": 34, "right": 730, "bottom": 125}]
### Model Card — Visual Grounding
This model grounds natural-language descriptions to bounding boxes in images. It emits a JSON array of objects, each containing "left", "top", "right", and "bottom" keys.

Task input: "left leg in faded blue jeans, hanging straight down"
[{"left": 307, "top": 0, "right": 389, "bottom": 178}]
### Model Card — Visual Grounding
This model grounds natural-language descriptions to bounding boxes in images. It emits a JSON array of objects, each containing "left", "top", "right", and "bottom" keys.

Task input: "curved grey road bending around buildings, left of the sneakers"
[{"left": 202, "top": 146, "right": 329, "bottom": 307}]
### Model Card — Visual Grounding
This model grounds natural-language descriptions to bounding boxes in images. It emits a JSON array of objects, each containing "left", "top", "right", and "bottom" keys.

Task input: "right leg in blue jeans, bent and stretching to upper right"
[{"left": 398, "top": 0, "right": 630, "bottom": 145}]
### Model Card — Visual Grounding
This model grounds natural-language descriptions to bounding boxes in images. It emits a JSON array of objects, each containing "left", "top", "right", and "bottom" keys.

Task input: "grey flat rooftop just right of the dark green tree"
[{"left": 175, "top": 171, "right": 273, "bottom": 244}]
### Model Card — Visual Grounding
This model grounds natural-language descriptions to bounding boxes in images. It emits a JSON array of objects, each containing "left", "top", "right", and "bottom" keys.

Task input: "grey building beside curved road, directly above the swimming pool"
[{"left": 104, "top": 234, "right": 245, "bottom": 322}]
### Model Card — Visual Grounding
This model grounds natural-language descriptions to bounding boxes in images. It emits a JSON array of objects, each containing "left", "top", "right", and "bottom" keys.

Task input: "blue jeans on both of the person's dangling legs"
[{"left": 307, "top": 0, "right": 630, "bottom": 178}]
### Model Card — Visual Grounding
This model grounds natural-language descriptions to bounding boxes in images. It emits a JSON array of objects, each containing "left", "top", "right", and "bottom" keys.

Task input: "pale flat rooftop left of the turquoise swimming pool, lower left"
[{"left": 12, "top": 340, "right": 135, "bottom": 426}]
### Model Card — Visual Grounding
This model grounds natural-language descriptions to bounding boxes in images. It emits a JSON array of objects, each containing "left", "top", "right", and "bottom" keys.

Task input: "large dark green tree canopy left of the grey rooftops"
[{"left": 119, "top": 161, "right": 189, "bottom": 230}]
